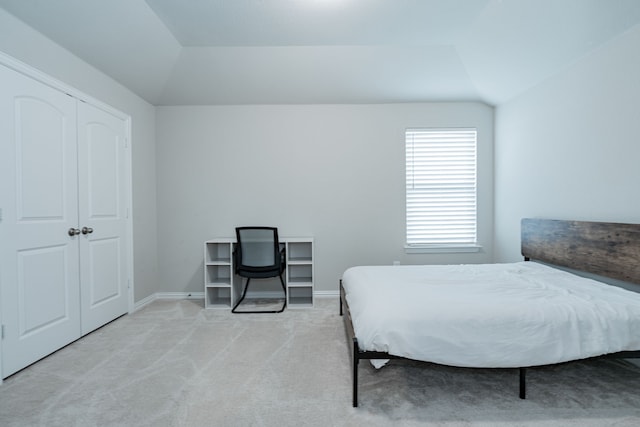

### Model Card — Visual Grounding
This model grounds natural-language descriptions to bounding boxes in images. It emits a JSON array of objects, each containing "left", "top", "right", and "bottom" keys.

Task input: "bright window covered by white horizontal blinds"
[{"left": 405, "top": 129, "right": 478, "bottom": 251}]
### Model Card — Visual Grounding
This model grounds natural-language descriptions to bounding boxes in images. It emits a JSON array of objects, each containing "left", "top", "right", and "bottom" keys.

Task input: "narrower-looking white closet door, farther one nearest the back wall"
[{"left": 78, "top": 103, "right": 128, "bottom": 335}]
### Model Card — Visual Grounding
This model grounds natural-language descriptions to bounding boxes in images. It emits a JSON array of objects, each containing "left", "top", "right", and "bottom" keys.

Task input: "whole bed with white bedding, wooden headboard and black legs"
[{"left": 340, "top": 219, "right": 640, "bottom": 407}]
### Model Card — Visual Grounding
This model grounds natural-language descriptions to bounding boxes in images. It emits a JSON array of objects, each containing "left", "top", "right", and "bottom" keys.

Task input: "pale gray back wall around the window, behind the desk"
[{"left": 156, "top": 103, "right": 493, "bottom": 292}]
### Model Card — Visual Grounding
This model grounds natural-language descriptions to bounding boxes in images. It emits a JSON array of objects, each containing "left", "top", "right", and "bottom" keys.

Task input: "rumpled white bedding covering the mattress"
[{"left": 342, "top": 262, "right": 640, "bottom": 368}]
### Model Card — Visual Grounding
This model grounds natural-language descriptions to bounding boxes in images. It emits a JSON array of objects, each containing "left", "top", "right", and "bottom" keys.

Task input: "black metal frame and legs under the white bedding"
[{"left": 340, "top": 280, "right": 640, "bottom": 408}]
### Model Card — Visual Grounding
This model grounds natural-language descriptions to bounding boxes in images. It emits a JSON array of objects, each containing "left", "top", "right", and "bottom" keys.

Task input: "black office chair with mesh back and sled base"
[{"left": 231, "top": 227, "right": 287, "bottom": 313}]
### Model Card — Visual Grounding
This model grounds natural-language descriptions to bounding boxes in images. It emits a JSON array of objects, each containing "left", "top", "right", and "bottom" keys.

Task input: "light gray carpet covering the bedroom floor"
[{"left": 0, "top": 299, "right": 640, "bottom": 427}]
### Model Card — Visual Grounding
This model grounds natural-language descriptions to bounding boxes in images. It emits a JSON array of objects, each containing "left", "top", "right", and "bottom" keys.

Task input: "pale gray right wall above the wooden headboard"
[{"left": 495, "top": 26, "right": 640, "bottom": 261}]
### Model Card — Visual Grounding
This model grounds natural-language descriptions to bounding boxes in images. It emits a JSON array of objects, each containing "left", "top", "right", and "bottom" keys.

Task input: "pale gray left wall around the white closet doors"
[{"left": 0, "top": 9, "right": 157, "bottom": 301}]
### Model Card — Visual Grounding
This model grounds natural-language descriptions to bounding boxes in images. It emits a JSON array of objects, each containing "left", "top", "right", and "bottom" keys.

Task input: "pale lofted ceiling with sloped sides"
[{"left": 0, "top": 0, "right": 640, "bottom": 105}]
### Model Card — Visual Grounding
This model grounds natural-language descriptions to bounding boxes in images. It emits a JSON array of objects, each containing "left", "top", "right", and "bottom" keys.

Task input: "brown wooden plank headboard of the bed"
[{"left": 521, "top": 218, "right": 640, "bottom": 284}]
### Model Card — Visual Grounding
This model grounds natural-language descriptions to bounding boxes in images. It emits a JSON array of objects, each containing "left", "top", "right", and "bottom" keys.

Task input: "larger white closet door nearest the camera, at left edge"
[{"left": 0, "top": 65, "right": 81, "bottom": 377}]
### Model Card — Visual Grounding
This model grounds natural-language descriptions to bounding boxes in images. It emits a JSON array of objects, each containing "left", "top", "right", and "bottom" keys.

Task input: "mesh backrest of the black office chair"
[{"left": 236, "top": 227, "right": 281, "bottom": 269}]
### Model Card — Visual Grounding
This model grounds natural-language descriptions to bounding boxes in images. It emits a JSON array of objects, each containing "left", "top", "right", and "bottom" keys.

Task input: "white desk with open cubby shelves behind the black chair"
[{"left": 204, "top": 237, "right": 315, "bottom": 310}]
